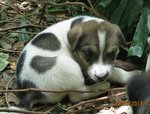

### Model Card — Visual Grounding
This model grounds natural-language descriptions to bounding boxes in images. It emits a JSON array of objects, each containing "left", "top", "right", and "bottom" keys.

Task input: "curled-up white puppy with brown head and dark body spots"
[{"left": 16, "top": 16, "right": 126, "bottom": 108}]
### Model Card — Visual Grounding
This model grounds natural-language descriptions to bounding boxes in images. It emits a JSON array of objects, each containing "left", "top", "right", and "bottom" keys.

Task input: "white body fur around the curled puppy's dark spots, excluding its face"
[{"left": 20, "top": 16, "right": 109, "bottom": 103}]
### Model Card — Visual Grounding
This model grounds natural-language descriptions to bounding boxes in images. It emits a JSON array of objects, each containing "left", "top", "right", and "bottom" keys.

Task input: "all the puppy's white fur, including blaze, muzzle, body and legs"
[{"left": 3, "top": 16, "right": 150, "bottom": 114}]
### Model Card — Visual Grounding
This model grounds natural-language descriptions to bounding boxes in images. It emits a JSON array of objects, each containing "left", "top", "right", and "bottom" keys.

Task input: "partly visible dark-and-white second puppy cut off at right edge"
[{"left": 127, "top": 37, "right": 150, "bottom": 114}]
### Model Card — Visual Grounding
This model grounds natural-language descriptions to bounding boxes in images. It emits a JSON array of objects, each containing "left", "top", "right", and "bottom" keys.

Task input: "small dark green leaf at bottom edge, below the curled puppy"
[{"left": 49, "top": 103, "right": 68, "bottom": 114}]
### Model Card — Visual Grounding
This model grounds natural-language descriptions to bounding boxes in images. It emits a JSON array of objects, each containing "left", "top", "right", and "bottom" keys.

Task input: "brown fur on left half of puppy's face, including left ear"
[{"left": 68, "top": 21, "right": 100, "bottom": 70}]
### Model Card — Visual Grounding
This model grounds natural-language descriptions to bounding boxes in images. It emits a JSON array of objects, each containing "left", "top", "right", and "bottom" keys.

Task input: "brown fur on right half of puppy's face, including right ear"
[{"left": 99, "top": 21, "right": 127, "bottom": 64}]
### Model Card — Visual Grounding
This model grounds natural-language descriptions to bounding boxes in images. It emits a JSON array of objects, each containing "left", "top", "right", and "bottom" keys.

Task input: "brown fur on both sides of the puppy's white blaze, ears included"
[{"left": 68, "top": 20, "right": 126, "bottom": 70}]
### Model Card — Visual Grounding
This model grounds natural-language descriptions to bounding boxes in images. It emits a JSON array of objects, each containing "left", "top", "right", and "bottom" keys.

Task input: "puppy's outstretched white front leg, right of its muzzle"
[{"left": 109, "top": 67, "right": 141, "bottom": 84}]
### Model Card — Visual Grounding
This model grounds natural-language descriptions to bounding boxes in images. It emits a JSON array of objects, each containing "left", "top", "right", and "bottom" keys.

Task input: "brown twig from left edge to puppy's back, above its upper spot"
[{"left": 0, "top": 24, "right": 46, "bottom": 32}]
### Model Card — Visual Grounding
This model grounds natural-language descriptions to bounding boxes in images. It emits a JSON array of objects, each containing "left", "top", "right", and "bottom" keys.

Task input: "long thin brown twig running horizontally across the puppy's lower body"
[{"left": 0, "top": 88, "right": 125, "bottom": 93}]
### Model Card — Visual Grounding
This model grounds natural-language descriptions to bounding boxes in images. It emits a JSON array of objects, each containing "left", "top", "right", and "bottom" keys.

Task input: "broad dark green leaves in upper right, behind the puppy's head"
[{"left": 95, "top": 0, "right": 150, "bottom": 57}]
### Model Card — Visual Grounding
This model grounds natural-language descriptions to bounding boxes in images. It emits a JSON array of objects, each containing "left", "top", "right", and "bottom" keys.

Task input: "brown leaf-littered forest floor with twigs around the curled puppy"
[{"left": 0, "top": 0, "right": 143, "bottom": 114}]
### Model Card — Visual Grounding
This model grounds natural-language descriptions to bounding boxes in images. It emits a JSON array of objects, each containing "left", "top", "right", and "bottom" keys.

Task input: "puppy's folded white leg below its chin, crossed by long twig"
[{"left": 69, "top": 81, "right": 110, "bottom": 102}]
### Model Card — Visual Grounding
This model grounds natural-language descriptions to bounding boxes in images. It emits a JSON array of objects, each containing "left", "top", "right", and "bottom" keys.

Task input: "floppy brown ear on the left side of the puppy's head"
[{"left": 67, "top": 25, "right": 83, "bottom": 51}]
